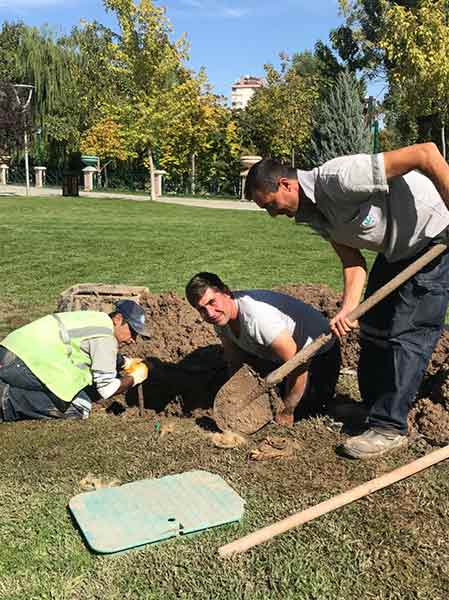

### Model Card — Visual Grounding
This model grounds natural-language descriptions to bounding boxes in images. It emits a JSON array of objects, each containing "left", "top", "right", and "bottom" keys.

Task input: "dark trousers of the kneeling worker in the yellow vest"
[{"left": 0, "top": 346, "right": 83, "bottom": 421}]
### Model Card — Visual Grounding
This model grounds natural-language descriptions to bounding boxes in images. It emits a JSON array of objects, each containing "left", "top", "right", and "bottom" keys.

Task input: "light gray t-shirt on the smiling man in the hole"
[{"left": 214, "top": 290, "right": 334, "bottom": 364}]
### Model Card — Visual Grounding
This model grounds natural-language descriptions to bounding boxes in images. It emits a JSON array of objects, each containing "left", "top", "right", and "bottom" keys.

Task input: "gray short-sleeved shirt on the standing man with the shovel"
[{"left": 296, "top": 154, "right": 449, "bottom": 262}]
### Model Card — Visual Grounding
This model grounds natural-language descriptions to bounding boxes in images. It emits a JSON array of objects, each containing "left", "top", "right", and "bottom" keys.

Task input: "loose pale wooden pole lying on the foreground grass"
[{"left": 218, "top": 446, "right": 449, "bottom": 557}]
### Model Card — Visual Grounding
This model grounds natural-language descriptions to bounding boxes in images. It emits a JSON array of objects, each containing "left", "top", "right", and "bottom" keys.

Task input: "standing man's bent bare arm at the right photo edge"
[{"left": 384, "top": 142, "right": 449, "bottom": 208}]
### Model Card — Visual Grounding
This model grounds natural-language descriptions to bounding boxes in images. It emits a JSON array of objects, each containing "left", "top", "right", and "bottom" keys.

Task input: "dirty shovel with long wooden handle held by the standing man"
[{"left": 214, "top": 244, "right": 447, "bottom": 434}]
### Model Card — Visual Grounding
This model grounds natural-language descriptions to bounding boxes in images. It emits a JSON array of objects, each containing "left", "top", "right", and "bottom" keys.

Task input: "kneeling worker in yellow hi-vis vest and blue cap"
[{"left": 0, "top": 300, "right": 148, "bottom": 422}]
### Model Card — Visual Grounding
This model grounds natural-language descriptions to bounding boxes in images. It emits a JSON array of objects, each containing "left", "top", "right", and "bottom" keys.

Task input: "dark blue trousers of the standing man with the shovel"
[{"left": 358, "top": 248, "right": 449, "bottom": 434}]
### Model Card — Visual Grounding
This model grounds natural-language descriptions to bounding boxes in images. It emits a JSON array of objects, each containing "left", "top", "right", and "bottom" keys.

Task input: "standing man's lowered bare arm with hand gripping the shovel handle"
[{"left": 330, "top": 242, "right": 367, "bottom": 337}]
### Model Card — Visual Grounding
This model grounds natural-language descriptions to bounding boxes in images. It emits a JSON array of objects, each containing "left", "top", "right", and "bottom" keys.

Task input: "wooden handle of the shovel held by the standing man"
[{"left": 265, "top": 244, "right": 447, "bottom": 387}]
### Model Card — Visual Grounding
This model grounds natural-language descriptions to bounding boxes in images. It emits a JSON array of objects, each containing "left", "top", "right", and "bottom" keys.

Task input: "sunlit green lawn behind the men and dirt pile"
[{"left": 0, "top": 193, "right": 341, "bottom": 334}]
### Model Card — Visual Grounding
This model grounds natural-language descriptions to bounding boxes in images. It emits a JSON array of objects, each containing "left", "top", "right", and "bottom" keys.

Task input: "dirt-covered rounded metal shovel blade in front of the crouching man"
[{"left": 214, "top": 365, "right": 278, "bottom": 434}]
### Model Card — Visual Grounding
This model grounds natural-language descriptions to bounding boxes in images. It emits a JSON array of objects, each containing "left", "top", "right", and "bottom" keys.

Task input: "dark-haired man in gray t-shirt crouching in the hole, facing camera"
[{"left": 186, "top": 272, "right": 340, "bottom": 425}]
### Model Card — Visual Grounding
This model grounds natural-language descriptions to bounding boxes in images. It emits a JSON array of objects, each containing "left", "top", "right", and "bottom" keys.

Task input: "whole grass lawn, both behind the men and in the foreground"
[{"left": 0, "top": 198, "right": 449, "bottom": 600}]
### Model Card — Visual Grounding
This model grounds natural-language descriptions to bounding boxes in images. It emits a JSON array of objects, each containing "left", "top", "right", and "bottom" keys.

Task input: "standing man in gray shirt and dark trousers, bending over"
[{"left": 245, "top": 143, "right": 449, "bottom": 458}]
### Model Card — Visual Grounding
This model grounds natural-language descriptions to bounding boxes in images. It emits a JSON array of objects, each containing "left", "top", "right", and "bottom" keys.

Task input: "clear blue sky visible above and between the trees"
[{"left": 0, "top": 0, "right": 384, "bottom": 98}]
